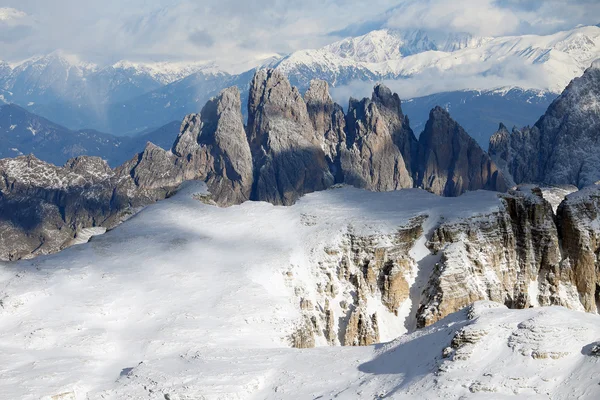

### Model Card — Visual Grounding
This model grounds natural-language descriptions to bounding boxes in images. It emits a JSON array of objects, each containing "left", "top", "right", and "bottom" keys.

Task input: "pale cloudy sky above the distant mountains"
[{"left": 0, "top": 0, "right": 600, "bottom": 64}]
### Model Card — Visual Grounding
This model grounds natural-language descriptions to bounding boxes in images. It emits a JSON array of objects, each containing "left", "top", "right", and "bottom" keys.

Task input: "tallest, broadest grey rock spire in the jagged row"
[{"left": 248, "top": 70, "right": 334, "bottom": 205}]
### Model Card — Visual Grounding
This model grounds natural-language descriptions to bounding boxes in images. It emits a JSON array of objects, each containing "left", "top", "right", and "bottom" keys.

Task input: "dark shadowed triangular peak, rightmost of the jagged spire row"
[{"left": 417, "top": 107, "right": 507, "bottom": 196}]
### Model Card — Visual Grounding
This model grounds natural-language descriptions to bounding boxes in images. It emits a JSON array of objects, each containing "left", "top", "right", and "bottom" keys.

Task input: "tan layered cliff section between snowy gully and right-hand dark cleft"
[{"left": 418, "top": 187, "right": 579, "bottom": 326}]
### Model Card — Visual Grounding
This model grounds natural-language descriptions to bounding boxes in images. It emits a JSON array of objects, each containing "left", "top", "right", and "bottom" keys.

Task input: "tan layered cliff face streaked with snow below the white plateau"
[{"left": 284, "top": 186, "right": 600, "bottom": 346}]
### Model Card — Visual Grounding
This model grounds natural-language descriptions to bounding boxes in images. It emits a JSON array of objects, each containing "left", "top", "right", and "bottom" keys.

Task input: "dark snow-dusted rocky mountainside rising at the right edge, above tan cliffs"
[{"left": 489, "top": 61, "right": 600, "bottom": 188}]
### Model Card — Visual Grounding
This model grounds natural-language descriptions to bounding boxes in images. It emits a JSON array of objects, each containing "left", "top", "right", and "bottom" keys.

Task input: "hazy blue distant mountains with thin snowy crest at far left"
[{"left": 0, "top": 51, "right": 227, "bottom": 133}]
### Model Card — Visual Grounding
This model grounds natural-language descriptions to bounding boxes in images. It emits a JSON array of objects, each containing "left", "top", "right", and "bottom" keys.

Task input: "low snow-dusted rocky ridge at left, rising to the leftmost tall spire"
[{"left": 0, "top": 88, "right": 252, "bottom": 260}]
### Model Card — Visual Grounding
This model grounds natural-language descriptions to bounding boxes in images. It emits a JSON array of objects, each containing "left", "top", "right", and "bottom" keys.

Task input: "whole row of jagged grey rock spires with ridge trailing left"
[{"left": 0, "top": 70, "right": 516, "bottom": 260}]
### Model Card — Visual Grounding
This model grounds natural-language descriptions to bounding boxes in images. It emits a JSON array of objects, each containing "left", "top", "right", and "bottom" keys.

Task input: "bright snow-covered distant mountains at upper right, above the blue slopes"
[{"left": 278, "top": 26, "right": 600, "bottom": 97}]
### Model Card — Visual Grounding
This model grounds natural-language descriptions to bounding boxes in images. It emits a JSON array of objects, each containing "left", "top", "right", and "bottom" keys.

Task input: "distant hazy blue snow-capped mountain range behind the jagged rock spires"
[{"left": 0, "top": 26, "right": 600, "bottom": 146}]
